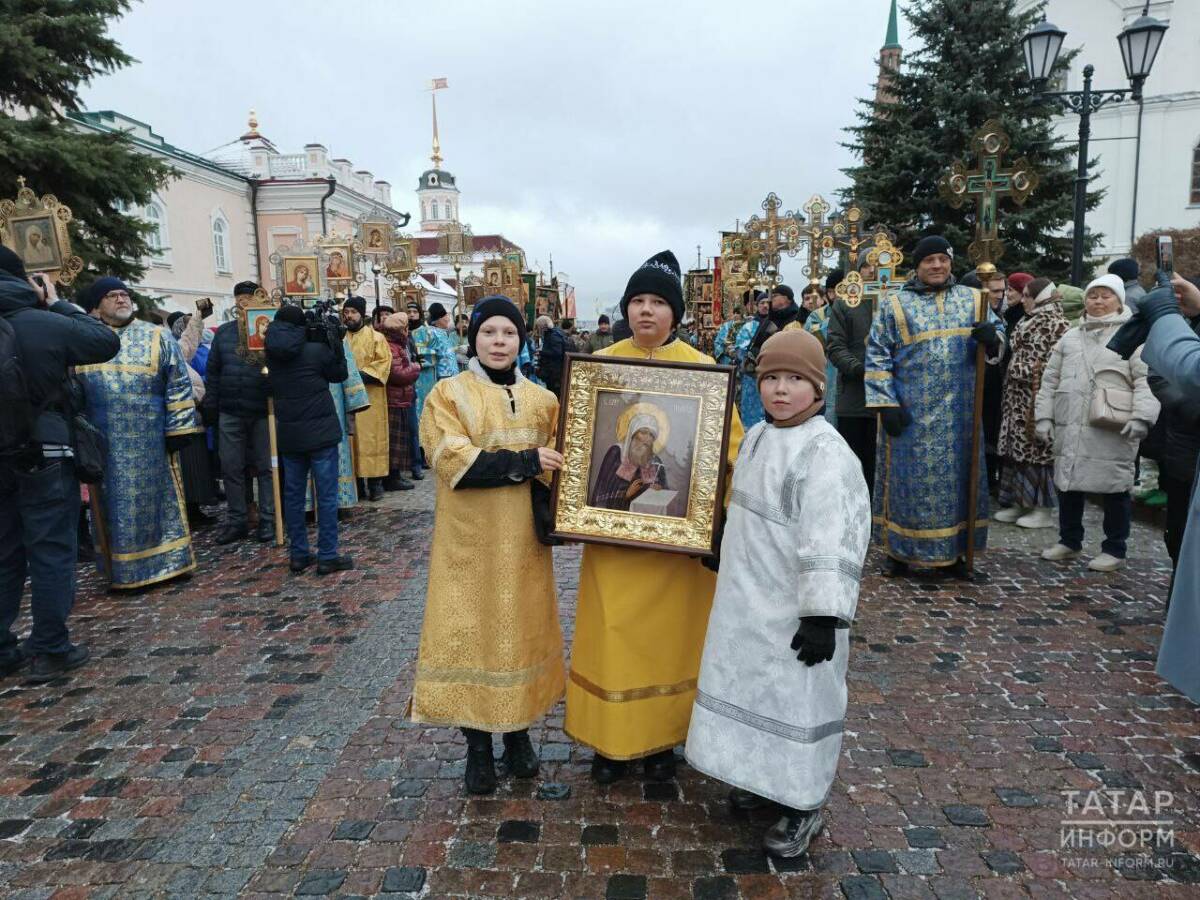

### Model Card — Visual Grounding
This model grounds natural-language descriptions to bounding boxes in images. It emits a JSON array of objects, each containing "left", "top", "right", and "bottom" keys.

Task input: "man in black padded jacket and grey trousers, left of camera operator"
[{"left": 202, "top": 281, "right": 275, "bottom": 544}]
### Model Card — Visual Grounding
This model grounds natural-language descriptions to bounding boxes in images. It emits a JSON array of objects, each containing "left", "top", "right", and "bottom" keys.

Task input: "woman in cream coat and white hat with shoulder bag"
[{"left": 1034, "top": 275, "right": 1160, "bottom": 572}]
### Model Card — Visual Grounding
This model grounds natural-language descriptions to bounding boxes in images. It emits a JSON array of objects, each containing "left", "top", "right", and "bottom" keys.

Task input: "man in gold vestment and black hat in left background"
[{"left": 342, "top": 296, "right": 391, "bottom": 500}]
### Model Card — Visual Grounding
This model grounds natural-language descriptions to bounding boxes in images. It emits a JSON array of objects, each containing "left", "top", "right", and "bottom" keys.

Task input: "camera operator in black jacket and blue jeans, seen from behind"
[{"left": 266, "top": 304, "right": 354, "bottom": 575}]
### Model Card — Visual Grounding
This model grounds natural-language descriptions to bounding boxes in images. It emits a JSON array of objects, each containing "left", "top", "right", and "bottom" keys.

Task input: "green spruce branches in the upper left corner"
[{"left": 0, "top": 0, "right": 173, "bottom": 300}]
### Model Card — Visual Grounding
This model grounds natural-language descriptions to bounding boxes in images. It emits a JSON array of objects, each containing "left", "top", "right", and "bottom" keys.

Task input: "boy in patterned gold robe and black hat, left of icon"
[{"left": 413, "top": 296, "right": 564, "bottom": 793}]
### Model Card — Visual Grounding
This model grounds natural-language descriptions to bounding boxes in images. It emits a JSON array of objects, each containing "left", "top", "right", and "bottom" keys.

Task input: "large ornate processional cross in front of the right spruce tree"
[{"left": 937, "top": 119, "right": 1038, "bottom": 266}]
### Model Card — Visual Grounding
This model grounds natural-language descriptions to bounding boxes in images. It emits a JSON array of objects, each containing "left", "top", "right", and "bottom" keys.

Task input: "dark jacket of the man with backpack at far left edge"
[{"left": 0, "top": 271, "right": 121, "bottom": 444}]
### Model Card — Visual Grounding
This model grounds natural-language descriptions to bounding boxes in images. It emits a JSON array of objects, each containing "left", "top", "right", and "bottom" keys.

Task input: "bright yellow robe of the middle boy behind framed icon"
[{"left": 563, "top": 340, "right": 742, "bottom": 760}]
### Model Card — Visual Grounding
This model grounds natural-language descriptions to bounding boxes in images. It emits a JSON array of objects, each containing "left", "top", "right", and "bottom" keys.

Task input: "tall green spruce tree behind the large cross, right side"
[{"left": 842, "top": 0, "right": 1100, "bottom": 281}]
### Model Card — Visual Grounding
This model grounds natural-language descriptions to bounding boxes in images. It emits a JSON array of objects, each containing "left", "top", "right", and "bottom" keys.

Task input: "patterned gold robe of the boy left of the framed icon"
[{"left": 413, "top": 360, "right": 564, "bottom": 732}]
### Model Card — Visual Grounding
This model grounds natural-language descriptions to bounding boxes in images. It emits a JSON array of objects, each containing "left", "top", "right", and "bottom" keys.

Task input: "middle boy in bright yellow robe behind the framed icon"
[{"left": 563, "top": 251, "right": 742, "bottom": 784}]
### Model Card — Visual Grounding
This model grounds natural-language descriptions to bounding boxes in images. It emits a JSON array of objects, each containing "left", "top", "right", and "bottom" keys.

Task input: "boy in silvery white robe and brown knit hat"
[{"left": 686, "top": 330, "right": 871, "bottom": 857}]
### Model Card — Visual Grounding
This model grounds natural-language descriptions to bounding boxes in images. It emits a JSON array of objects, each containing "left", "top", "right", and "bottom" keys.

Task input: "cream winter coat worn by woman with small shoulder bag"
[{"left": 1036, "top": 306, "right": 1160, "bottom": 493}]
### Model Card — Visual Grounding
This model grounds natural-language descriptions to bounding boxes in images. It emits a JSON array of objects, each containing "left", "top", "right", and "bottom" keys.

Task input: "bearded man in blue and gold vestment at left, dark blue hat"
[{"left": 76, "top": 277, "right": 203, "bottom": 589}]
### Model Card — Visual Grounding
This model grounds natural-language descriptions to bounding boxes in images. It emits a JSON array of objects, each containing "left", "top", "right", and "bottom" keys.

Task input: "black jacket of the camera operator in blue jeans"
[{"left": 266, "top": 322, "right": 349, "bottom": 454}]
